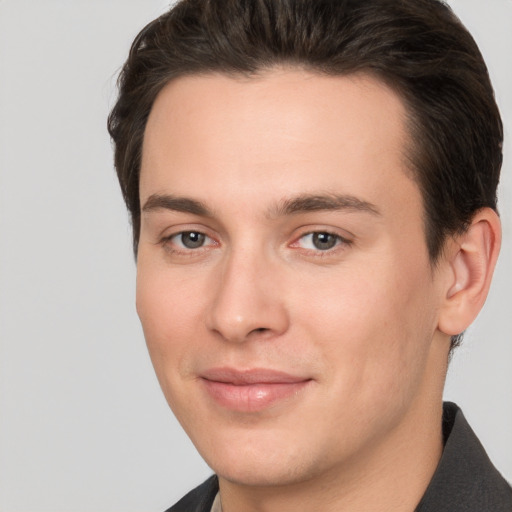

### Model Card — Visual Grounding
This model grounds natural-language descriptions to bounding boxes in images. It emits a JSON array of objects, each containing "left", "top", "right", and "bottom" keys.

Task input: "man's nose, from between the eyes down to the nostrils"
[{"left": 207, "top": 246, "right": 289, "bottom": 343}]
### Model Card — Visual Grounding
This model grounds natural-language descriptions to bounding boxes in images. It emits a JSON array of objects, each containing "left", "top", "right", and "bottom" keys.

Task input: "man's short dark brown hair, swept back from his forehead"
[{"left": 108, "top": 0, "right": 503, "bottom": 348}]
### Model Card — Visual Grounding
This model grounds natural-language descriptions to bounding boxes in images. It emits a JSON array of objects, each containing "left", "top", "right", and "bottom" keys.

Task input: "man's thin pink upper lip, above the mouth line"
[{"left": 200, "top": 368, "right": 311, "bottom": 386}]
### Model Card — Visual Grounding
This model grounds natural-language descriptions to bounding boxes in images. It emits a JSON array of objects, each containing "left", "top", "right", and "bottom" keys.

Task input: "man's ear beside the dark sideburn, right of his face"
[{"left": 438, "top": 208, "right": 501, "bottom": 336}]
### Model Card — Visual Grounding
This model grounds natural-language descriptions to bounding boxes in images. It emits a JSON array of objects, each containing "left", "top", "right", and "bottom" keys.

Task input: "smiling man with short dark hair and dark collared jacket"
[{"left": 109, "top": 0, "right": 512, "bottom": 512}]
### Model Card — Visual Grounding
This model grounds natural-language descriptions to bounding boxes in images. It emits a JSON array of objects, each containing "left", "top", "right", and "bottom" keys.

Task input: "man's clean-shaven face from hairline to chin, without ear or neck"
[{"left": 137, "top": 70, "right": 446, "bottom": 485}]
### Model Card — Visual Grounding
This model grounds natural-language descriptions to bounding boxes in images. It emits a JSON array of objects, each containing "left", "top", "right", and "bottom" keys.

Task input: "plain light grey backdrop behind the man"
[{"left": 0, "top": 0, "right": 512, "bottom": 512}]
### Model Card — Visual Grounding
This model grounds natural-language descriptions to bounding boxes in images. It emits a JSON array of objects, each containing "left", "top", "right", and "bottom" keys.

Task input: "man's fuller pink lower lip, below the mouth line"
[{"left": 203, "top": 379, "right": 310, "bottom": 412}]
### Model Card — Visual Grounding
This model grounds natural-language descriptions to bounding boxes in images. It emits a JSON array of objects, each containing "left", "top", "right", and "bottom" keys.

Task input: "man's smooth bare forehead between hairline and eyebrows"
[{"left": 140, "top": 69, "right": 417, "bottom": 220}]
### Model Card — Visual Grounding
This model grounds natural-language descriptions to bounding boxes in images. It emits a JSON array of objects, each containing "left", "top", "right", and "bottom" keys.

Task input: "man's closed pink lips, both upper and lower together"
[{"left": 200, "top": 368, "right": 312, "bottom": 412}]
